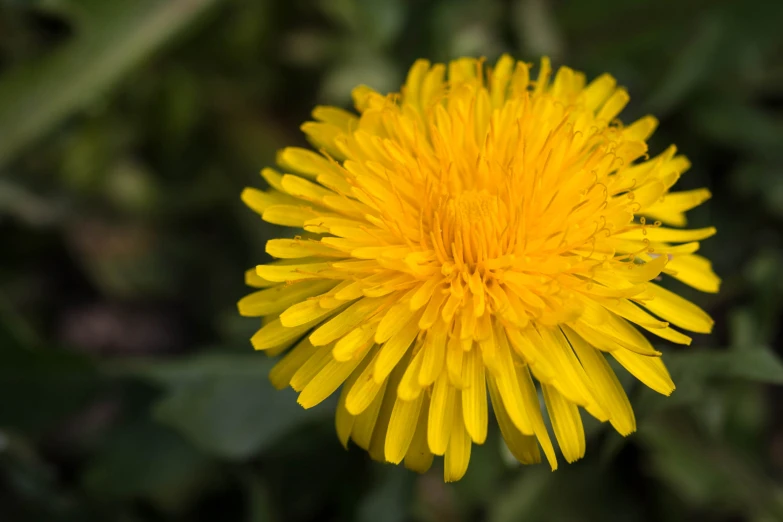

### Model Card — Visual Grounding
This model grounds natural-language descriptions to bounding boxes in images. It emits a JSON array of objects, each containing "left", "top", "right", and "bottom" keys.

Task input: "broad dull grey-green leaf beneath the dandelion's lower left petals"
[{"left": 145, "top": 354, "right": 330, "bottom": 459}]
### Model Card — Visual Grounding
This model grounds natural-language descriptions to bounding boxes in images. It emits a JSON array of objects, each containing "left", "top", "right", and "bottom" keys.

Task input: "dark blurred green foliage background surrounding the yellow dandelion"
[{"left": 0, "top": 0, "right": 783, "bottom": 522}]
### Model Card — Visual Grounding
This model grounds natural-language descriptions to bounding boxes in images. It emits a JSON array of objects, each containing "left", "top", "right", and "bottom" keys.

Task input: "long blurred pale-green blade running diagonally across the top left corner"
[{"left": 0, "top": 0, "right": 217, "bottom": 165}]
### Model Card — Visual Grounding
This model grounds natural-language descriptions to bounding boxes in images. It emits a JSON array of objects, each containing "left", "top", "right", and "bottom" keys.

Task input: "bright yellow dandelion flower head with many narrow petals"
[{"left": 239, "top": 56, "right": 719, "bottom": 481}]
